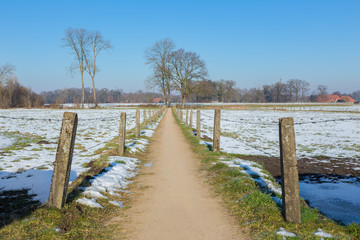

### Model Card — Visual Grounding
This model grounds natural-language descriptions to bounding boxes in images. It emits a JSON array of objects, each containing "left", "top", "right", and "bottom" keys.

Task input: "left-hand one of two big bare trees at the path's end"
[{"left": 145, "top": 39, "right": 175, "bottom": 106}]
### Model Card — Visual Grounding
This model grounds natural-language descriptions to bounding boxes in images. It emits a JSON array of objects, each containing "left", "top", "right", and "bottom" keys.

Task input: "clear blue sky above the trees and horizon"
[{"left": 0, "top": 0, "right": 360, "bottom": 93}]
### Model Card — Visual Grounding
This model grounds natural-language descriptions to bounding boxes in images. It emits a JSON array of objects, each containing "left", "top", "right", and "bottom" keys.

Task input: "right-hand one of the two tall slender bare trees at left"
[{"left": 84, "top": 31, "right": 111, "bottom": 107}]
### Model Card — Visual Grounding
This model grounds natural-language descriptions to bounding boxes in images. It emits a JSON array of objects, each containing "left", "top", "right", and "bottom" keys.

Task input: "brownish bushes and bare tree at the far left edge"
[{"left": 0, "top": 64, "right": 44, "bottom": 108}]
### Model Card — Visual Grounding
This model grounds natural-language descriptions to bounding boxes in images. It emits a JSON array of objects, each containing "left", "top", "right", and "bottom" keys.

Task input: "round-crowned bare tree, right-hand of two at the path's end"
[{"left": 170, "top": 49, "right": 207, "bottom": 107}]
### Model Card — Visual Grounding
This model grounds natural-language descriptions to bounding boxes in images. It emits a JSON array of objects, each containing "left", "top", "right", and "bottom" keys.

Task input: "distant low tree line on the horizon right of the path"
[{"left": 189, "top": 79, "right": 360, "bottom": 103}]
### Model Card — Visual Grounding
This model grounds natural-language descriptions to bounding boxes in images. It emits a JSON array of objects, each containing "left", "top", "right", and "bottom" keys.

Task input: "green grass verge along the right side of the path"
[{"left": 174, "top": 108, "right": 360, "bottom": 239}]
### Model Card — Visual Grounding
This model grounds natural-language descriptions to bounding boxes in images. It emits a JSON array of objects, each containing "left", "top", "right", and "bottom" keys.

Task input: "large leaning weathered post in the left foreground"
[{"left": 47, "top": 112, "right": 78, "bottom": 209}]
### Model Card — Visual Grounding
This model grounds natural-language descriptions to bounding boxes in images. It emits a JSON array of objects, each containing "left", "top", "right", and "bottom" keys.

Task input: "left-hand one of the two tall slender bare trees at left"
[{"left": 62, "top": 28, "right": 89, "bottom": 108}]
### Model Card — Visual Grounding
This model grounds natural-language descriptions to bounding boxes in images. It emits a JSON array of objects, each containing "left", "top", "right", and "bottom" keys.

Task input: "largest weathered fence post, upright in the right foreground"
[{"left": 279, "top": 118, "right": 301, "bottom": 223}]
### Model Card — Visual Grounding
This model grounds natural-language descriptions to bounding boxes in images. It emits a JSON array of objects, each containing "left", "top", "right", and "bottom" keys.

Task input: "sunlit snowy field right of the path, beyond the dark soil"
[{"left": 193, "top": 110, "right": 360, "bottom": 160}]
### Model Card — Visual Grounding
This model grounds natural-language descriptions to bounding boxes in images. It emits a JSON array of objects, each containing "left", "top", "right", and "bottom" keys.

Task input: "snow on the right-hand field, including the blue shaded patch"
[{"left": 183, "top": 109, "right": 360, "bottom": 224}]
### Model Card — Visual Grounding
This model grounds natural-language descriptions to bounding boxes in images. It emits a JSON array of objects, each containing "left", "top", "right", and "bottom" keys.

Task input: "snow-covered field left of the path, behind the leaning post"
[{"left": 0, "top": 108, "right": 160, "bottom": 203}]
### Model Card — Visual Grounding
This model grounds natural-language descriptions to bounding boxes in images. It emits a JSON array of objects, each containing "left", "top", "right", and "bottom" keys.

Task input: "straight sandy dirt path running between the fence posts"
[{"left": 112, "top": 110, "right": 248, "bottom": 240}]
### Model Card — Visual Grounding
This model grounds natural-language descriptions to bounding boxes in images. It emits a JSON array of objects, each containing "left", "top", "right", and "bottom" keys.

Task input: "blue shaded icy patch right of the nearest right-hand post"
[{"left": 299, "top": 175, "right": 360, "bottom": 225}]
